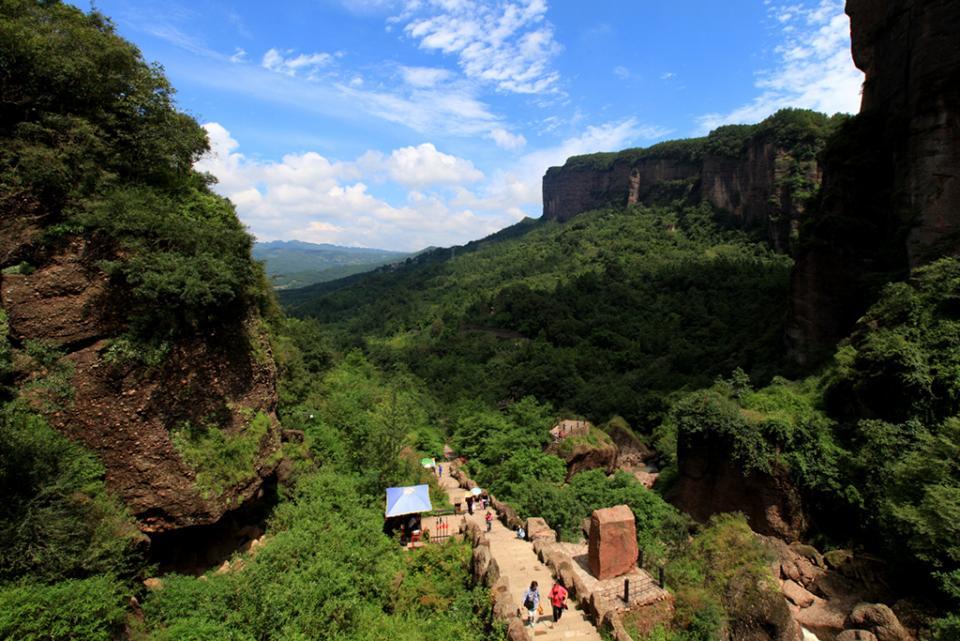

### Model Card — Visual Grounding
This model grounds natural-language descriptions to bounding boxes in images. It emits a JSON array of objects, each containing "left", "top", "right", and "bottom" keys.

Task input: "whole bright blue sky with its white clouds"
[{"left": 78, "top": 0, "right": 862, "bottom": 250}]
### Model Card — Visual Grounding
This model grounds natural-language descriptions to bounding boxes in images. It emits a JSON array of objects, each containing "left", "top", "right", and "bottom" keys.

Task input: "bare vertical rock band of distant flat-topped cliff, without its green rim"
[{"left": 543, "top": 140, "right": 821, "bottom": 251}]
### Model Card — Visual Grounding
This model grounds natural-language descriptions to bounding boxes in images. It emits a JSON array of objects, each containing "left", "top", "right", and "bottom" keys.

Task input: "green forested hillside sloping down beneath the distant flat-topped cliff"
[{"left": 281, "top": 206, "right": 791, "bottom": 424}]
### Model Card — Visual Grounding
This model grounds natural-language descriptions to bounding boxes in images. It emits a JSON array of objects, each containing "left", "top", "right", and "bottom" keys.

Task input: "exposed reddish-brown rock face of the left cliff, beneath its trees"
[{"left": 0, "top": 232, "right": 280, "bottom": 532}]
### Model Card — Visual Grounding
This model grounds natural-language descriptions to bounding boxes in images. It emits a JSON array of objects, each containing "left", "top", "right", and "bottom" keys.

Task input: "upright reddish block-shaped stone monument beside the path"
[{"left": 588, "top": 505, "right": 638, "bottom": 580}]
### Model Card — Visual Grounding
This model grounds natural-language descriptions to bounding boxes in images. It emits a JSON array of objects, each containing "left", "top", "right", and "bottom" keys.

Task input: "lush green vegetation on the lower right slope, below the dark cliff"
[{"left": 658, "top": 259, "right": 960, "bottom": 620}]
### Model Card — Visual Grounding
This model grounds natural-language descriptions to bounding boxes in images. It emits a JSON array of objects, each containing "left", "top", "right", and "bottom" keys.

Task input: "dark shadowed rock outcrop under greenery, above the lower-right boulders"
[{"left": 667, "top": 430, "right": 807, "bottom": 541}]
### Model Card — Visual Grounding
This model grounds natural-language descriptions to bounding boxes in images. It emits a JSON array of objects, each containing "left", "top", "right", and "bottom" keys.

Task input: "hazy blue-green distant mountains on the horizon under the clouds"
[{"left": 253, "top": 240, "right": 412, "bottom": 289}]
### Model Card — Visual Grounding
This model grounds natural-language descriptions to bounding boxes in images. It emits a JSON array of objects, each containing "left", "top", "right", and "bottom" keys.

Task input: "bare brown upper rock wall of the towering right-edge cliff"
[{"left": 847, "top": 0, "right": 960, "bottom": 266}]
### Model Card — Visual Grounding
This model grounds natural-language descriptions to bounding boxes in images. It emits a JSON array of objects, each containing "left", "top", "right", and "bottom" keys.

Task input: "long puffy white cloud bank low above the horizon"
[{"left": 197, "top": 118, "right": 666, "bottom": 250}]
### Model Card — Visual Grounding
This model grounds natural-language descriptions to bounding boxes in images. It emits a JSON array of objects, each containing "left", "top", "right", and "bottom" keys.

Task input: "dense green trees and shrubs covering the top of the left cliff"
[{"left": 0, "top": 0, "right": 262, "bottom": 339}]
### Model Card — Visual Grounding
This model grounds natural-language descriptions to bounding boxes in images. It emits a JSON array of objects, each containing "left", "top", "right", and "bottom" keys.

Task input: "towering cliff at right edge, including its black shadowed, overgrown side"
[{"left": 788, "top": 0, "right": 960, "bottom": 364}]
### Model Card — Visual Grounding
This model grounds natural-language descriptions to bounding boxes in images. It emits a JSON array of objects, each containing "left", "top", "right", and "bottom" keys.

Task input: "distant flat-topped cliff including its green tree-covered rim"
[{"left": 543, "top": 110, "right": 839, "bottom": 251}]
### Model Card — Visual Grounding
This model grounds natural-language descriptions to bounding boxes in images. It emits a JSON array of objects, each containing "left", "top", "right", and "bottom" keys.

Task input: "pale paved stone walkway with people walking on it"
[{"left": 440, "top": 466, "right": 600, "bottom": 641}]
